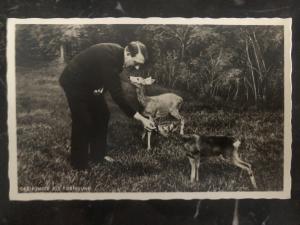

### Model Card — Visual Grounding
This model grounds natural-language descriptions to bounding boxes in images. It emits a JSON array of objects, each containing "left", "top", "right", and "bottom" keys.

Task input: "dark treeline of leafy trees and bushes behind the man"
[{"left": 16, "top": 25, "right": 284, "bottom": 109}]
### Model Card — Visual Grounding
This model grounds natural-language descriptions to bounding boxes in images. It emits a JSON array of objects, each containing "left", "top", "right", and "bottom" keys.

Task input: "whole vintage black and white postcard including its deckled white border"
[{"left": 7, "top": 18, "right": 292, "bottom": 200}]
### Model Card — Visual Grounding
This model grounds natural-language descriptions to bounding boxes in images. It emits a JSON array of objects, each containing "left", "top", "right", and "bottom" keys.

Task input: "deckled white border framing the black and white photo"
[{"left": 7, "top": 18, "right": 292, "bottom": 201}]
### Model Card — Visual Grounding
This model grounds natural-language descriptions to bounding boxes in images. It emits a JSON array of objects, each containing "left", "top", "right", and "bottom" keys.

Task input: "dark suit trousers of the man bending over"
[{"left": 65, "top": 89, "right": 110, "bottom": 169}]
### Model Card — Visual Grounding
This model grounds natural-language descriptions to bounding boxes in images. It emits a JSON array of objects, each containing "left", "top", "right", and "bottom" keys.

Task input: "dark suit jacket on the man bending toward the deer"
[{"left": 60, "top": 43, "right": 136, "bottom": 117}]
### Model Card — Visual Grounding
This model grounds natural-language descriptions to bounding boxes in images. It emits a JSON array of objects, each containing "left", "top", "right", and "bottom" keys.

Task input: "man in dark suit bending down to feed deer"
[{"left": 59, "top": 41, "right": 155, "bottom": 169}]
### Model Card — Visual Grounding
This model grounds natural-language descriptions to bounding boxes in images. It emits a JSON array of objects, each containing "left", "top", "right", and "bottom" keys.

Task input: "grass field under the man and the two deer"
[{"left": 16, "top": 60, "right": 283, "bottom": 192}]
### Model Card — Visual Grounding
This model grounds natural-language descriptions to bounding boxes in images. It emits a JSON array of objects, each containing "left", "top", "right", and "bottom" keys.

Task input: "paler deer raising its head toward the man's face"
[{"left": 130, "top": 76, "right": 184, "bottom": 150}]
